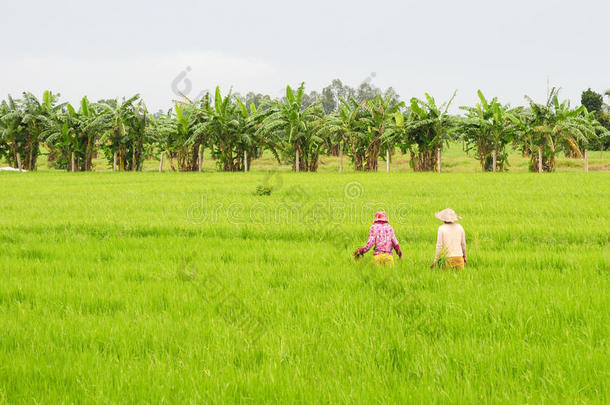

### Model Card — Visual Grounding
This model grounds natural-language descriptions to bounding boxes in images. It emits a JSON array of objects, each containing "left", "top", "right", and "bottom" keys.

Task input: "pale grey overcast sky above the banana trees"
[{"left": 0, "top": 0, "right": 610, "bottom": 111}]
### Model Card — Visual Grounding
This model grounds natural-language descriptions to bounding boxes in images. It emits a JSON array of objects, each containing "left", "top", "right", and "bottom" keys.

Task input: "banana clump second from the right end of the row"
[{"left": 458, "top": 90, "right": 517, "bottom": 171}]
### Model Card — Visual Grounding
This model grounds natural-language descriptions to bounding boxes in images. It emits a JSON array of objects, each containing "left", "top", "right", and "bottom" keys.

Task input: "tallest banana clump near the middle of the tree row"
[{"left": 257, "top": 83, "right": 324, "bottom": 172}]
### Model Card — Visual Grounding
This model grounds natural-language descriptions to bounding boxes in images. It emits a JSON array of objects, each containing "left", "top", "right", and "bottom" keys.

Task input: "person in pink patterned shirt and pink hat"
[{"left": 354, "top": 211, "right": 402, "bottom": 266}]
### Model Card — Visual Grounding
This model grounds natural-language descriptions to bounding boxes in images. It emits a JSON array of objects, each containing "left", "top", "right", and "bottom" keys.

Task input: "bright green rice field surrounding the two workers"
[{"left": 0, "top": 172, "right": 610, "bottom": 404}]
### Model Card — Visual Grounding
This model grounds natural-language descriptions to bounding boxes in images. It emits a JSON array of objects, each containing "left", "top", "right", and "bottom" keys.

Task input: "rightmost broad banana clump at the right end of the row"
[{"left": 513, "top": 88, "right": 597, "bottom": 172}]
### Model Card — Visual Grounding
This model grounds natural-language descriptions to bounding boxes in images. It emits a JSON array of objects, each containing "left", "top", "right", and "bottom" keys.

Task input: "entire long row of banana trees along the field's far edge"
[{"left": 0, "top": 83, "right": 608, "bottom": 172}]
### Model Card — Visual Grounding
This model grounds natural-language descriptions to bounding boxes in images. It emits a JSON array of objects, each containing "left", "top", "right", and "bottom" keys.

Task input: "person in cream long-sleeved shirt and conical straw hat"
[{"left": 432, "top": 208, "right": 466, "bottom": 269}]
